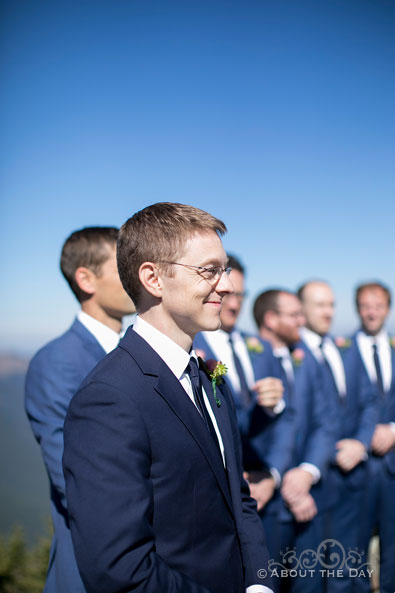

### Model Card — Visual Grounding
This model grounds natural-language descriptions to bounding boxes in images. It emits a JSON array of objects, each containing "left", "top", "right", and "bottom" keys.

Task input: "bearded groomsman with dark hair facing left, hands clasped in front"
[{"left": 254, "top": 289, "right": 334, "bottom": 593}]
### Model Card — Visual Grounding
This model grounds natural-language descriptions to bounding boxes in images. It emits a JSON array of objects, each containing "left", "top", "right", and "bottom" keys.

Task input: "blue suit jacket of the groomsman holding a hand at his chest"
[{"left": 194, "top": 334, "right": 294, "bottom": 512}]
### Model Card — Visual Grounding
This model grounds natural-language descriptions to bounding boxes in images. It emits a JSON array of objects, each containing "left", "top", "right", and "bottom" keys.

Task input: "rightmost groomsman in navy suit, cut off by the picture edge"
[{"left": 352, "top": 282, "right": 395, "bottom": 593}]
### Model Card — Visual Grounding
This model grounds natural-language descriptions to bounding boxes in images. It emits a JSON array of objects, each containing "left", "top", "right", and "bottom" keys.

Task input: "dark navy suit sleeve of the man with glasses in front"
[{"left": 63, "top": 383, "right": 213, "bottom": 593}]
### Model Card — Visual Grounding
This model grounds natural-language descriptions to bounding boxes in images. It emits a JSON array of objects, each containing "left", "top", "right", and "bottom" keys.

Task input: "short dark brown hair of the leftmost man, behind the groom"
[{"left": 60, "top": 227, "right": 119, "bottom": 303}]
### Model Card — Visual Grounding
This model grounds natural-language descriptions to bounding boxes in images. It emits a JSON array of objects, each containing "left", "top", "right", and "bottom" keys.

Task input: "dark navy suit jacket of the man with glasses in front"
[{"left": 63, "top": 328, "right": 274, "bottom": 593}]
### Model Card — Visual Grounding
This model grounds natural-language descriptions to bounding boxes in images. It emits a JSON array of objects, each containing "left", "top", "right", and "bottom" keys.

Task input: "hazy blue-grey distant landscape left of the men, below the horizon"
[{"left": 0, "top": 360, "right": 50, "bottom": 542}]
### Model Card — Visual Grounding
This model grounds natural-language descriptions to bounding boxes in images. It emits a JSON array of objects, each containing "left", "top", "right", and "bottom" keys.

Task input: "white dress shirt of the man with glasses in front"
[{"left": 133, "top": 315, "right": 273, "bottom": 593}]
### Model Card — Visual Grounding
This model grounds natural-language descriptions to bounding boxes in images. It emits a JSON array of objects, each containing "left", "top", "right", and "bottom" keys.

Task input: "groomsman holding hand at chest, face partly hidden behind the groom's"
[{"left": 194, "top": 254, "right": 292, "bottom": 511}]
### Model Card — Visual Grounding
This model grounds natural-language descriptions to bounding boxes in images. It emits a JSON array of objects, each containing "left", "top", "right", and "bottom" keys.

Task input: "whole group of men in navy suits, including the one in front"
[{"left": 26, "top": 203, "right": 395, "bottom": 593}]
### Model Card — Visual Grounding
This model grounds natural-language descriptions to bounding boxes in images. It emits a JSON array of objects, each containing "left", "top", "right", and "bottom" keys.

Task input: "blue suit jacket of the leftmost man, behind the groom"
[{"left": 25, "top": 319, "right": 105, "bottom": 593}]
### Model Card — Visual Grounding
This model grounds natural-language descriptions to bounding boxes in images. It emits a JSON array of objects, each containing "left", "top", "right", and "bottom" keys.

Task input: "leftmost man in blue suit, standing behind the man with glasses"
[{"left": 25, "top": 227, "right": 134, "bottom": 593}]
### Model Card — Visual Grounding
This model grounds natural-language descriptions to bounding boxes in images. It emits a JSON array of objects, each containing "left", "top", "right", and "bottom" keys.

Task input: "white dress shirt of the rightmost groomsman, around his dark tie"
[{"left": 356, "top": 329, "right": 392, "bottom": 392}]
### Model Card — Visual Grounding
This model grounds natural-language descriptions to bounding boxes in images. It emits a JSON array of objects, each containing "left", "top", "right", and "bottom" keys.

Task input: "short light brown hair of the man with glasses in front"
[{"left": 117, "top": 202, "right": 227, "bottom": 306}]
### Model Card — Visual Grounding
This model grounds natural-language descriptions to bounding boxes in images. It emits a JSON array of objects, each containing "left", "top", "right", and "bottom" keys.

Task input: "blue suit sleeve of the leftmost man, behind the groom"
[{"left": 25, "top": 350, "right": 81, "bottom": 508}]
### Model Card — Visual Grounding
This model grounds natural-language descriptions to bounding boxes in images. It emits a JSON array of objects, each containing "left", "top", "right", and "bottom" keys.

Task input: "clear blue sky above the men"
[{"left": 0, "top": 0, "right": 395, "bottom": 353}]
